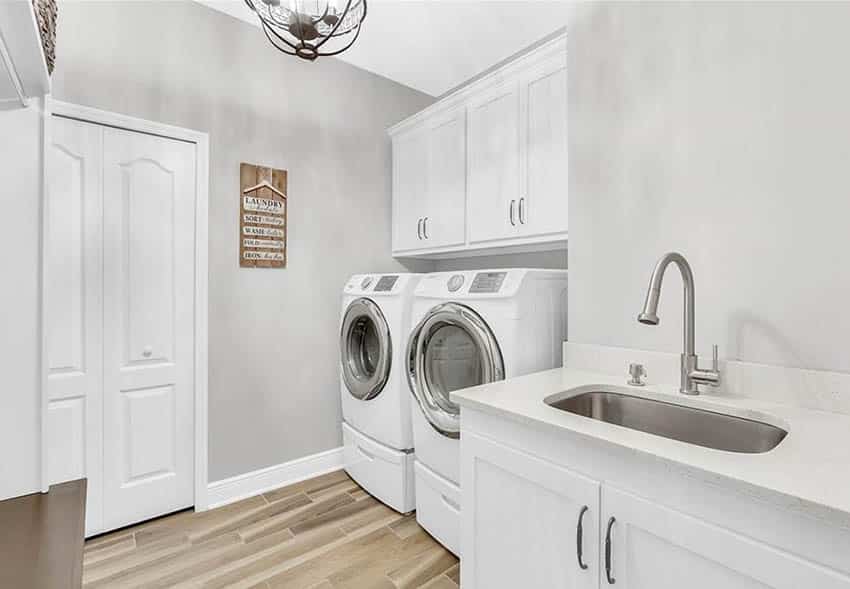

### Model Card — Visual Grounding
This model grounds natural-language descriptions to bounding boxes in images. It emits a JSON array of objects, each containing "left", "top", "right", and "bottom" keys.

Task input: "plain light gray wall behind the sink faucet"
[{"left": 568, "top": 2, "right": 850, "bottom": 371}]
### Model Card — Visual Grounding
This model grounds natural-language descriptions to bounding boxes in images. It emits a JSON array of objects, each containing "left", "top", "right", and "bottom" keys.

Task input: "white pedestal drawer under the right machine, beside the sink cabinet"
[{"left": 416, "top": 460, "right": 460, "bottom": 556}]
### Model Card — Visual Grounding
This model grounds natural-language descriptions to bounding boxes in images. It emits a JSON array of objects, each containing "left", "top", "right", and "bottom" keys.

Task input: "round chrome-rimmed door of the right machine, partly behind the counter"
[{"left": 407, "top": 303, "right": 505, "bottom": 438}]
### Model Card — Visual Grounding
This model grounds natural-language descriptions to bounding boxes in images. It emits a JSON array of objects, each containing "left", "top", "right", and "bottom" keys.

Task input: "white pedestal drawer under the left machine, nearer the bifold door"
[{"left": 342, "top": 423, "right": 416, "bottom": 513}]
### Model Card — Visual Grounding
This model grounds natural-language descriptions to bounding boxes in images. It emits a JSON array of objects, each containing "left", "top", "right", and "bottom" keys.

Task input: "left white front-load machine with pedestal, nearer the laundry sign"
[{"left": 340, "top": 274, "right": 420, "bottom": 513}]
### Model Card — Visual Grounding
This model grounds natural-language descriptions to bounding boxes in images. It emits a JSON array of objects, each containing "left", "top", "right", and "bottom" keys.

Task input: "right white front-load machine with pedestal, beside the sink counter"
[{"left": 404, "top": 269, "right": 567, "bottom": 555}]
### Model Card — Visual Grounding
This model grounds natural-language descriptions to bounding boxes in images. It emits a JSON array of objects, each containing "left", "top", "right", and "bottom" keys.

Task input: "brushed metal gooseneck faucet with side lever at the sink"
[{"left": 638, "top": 252, "right": 720, "bottom": 395}]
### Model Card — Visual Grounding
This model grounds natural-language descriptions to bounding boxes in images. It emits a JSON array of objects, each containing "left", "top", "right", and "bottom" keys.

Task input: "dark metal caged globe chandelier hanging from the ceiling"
[{"left": 245, "top": 0, "right": 366, "bottom": 61}]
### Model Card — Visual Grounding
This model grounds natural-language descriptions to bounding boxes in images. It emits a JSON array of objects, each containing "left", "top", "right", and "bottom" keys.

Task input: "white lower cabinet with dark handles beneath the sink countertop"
[{"left": 461, "top": 408, "right": 850, "bottom": 589}]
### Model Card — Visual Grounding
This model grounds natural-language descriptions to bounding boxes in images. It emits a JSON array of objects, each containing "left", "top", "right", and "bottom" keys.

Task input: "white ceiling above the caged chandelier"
[{"left": 197, "top": 0, "right": 572, "bottom": 96}]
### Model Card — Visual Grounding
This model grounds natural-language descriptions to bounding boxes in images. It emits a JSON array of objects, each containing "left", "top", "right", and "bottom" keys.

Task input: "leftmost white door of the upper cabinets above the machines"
[{"left": 393, "top": 129, "right": 428, "bottom": 252}]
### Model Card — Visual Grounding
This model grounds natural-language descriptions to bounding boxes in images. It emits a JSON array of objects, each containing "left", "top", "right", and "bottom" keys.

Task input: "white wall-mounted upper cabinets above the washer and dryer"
[{"left": 390, "top": 36, "right": 567, "bottom": 257}]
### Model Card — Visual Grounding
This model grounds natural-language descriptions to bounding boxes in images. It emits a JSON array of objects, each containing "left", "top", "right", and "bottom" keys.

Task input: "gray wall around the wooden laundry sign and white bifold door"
[{"left": 54, "top": 2, "right": 432, "bottom": 480}]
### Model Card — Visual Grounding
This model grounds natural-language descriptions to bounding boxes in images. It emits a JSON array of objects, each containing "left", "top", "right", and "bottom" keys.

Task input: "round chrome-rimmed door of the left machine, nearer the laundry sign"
[{"left": 339, "top": 298, "right": 393, "bottom": 401}]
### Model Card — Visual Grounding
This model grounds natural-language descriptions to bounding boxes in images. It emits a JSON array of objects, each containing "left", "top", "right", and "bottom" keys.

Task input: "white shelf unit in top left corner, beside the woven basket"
[{"left": 0, "top": 0, "right": 50, "bottom": 110}]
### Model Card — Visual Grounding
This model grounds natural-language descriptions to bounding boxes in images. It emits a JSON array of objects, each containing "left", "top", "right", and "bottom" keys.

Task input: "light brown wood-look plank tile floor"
[{"left": 83, "top": 471, "right": 460, "bottom": 589}]
